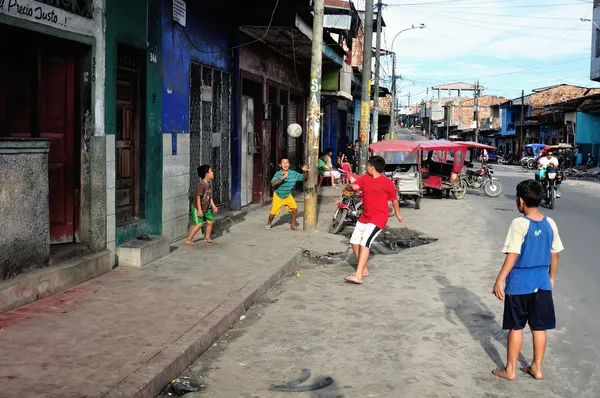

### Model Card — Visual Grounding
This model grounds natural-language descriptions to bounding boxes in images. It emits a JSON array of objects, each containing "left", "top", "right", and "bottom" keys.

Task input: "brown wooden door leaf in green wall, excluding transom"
[{"left": 116, "top": 68, "right": 139, "bottom": 224}]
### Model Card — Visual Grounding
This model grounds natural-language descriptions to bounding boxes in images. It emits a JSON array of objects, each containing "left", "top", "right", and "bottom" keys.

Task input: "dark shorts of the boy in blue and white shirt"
[{"left": 502, "top": 290, "right": 556, "bottom": 330}]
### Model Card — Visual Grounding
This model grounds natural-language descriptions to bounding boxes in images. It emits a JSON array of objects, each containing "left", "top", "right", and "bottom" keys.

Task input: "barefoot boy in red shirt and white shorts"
[{"left": 346, "top": 156, "right": 404, "bottom": 285}]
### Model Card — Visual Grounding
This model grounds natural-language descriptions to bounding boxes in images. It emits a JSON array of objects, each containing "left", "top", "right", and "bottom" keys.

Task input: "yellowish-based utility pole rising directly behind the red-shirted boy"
[{"left": 358, "top": 0, "right": 373, "bottom": 175}]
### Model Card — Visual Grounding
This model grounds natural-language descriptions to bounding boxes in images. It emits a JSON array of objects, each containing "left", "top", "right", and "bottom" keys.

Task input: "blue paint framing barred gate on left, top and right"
[{"left": 162, "top": 0, "right": 241, "bottom": 209}]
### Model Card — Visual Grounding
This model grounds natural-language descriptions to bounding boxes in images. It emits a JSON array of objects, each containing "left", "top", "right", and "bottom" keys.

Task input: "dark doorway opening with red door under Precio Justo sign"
[{"left": 0, "top": 24, "right": 84, "bottom": 243}]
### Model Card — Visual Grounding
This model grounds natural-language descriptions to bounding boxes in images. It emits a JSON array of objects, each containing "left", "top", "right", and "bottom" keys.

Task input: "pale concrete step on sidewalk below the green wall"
[{"left": 116, "top": 235, "right": 171, "bottom": 268}]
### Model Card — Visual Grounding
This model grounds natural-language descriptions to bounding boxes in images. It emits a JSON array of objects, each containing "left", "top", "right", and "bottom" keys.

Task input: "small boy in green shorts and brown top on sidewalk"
[{"left": 185, "top": 164, "right": 219, "bottom": 246}]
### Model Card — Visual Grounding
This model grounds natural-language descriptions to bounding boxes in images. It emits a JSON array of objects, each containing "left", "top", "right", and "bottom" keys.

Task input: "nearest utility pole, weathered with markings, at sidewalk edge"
[{"left": 303, "top": 0, "right": 325, "bottom": 231}]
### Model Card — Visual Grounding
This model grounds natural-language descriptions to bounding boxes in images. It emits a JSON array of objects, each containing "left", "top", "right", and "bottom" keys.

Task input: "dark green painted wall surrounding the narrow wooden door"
[{"left": 105, "top": 0, "right": 163, "bottom": 245}]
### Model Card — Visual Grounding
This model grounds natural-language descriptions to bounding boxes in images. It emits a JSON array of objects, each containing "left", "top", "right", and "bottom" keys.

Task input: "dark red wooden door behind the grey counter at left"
[{"left": 38, "top": 54, "right": 76, "bottom": 243}]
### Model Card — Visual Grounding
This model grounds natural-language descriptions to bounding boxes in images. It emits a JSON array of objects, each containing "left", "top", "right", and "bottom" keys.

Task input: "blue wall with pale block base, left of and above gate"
[{"left": 162, "top": 0, "right": 233, "bottom": 241}]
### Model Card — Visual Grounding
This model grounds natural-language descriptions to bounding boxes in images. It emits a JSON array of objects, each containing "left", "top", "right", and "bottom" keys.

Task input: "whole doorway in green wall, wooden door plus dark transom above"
[{"left": 115, "top": 45, "right": 145, "bottom": 225}]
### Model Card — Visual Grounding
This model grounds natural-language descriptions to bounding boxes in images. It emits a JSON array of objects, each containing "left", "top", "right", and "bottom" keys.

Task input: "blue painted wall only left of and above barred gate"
[{"left": 162, "top": 0, "right": 233, "bottom": 134}]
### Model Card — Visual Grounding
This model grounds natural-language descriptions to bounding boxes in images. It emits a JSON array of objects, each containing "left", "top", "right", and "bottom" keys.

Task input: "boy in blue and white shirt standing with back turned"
[{"left": 492, "top": 180, "right": 564, "bottom": 380}]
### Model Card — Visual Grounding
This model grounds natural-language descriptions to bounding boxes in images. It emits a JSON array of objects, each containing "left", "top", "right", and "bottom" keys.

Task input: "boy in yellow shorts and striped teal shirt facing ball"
[{"left": 265, "top": 157, "right": 308, "bottom": 231}]
